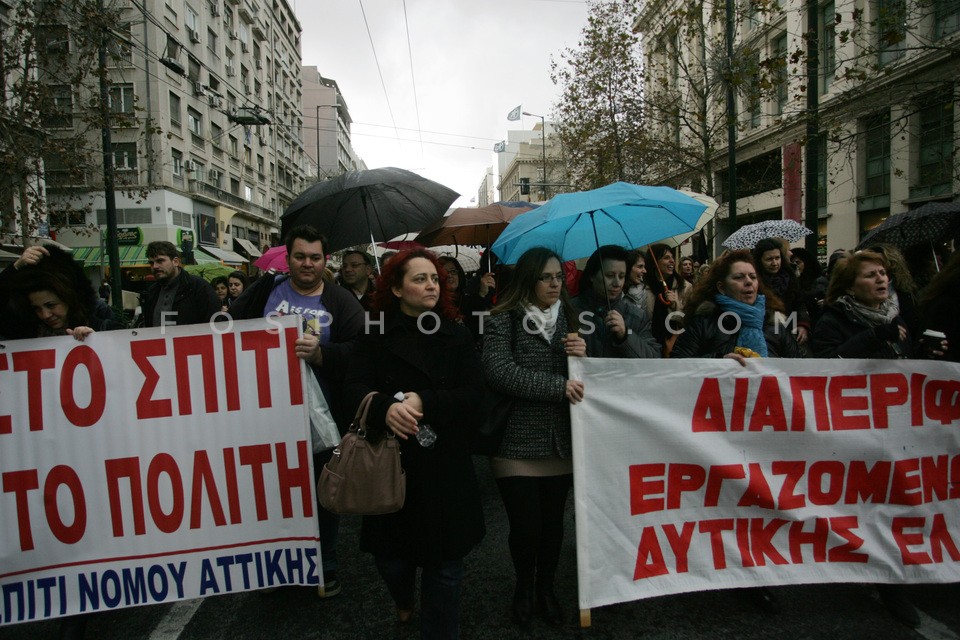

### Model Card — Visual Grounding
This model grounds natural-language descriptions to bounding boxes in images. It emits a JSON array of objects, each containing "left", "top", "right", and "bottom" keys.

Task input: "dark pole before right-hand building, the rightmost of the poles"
[{"left": 803, "top": 0, "right": 820, "bottom": 256}]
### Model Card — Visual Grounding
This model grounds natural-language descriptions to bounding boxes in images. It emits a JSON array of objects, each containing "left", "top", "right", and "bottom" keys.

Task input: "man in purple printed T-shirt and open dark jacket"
[{"left": 230, "top": 225, "right": 364, "bottom": 598}]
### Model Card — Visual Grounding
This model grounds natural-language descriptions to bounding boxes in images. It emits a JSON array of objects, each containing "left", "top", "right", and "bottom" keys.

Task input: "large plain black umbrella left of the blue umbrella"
[{"left": 281, "top": 167, "right": 459, "bottom": 252}]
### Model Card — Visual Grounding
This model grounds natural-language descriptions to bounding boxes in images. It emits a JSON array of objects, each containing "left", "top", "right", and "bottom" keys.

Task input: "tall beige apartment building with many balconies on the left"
[{"left": 45, "top": 0, "right": 308, "bottom": 289}]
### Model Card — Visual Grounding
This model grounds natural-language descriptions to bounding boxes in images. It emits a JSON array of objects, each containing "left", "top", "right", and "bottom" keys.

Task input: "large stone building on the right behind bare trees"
[{"left": 634, "top": 0, "right": 960, "bottom": 256}]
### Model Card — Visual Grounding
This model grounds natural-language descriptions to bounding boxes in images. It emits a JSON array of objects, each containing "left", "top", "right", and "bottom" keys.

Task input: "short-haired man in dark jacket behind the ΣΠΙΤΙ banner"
[{"left": 140, "top": 240, "right": 220, "bottom": 327}]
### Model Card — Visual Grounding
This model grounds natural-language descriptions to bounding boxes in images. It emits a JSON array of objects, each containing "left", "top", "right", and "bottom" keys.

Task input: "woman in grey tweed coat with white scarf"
[{"left": 483, "top": 248, "right": 587, "bottom": 627}]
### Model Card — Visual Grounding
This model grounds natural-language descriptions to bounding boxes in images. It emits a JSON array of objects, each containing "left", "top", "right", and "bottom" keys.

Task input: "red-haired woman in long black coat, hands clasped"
[{"left": 345, "top": 249, "right": 485, "bottom": 638}]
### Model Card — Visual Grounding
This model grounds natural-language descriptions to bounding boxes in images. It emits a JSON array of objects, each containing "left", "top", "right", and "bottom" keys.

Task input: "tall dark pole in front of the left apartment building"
[{"left": 97, "top": 0, "right": 123, "bottom": 317}]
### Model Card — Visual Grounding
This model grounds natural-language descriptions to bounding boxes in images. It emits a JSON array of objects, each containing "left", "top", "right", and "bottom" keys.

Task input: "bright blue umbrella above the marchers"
[{"left": 493, "top": 182, "right": 706, "bottom": 264}]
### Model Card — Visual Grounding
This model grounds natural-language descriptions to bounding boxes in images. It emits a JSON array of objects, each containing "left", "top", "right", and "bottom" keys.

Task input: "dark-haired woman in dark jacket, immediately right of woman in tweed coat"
[{"left": 573, "top": 244, "right": 660, "bottom": 358}]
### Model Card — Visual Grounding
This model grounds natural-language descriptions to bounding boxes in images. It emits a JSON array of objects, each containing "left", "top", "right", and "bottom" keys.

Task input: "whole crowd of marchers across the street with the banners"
[{"left": 0, "top": 226, "right": 960, "bottom": 638}]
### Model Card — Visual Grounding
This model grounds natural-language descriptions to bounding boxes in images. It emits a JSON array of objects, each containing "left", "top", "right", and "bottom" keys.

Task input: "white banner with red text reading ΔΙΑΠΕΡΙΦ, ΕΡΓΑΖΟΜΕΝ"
[{"left": 569, "top": 358, "right": 960, "bottom": 609}]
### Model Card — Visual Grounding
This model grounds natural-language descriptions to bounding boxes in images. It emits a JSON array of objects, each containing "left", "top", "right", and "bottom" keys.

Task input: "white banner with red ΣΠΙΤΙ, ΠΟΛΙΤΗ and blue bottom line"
[{"left": 0, "top": 316, "right": 322, "bottom": 625}]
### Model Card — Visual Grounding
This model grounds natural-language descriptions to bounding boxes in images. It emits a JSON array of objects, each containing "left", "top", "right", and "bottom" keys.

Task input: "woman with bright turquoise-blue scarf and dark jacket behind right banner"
[{"left": 670, "top": 249, "right": 801, "bottom": 364}]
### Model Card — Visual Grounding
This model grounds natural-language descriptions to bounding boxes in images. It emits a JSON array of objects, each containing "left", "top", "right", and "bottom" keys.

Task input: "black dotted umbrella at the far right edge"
[{"left": 857, "top": 202, "right": 960, "bottom": 251}]
